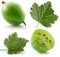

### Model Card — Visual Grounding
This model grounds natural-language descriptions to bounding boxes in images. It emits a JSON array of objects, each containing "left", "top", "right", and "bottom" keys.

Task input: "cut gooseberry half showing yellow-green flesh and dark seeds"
[{"left": 31, "top": 29, "right": 55, "bottom": 53}]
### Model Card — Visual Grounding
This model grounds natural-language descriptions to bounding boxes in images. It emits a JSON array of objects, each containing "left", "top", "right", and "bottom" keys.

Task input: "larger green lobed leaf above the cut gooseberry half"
[{"left": 30, "top": 1, "right": 58, "bottom": 27}]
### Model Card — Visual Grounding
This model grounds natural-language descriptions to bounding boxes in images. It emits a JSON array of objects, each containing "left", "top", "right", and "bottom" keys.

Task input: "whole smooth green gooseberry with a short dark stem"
[{"left": 2, "top": 2, "right": 26, "bottom": 26}]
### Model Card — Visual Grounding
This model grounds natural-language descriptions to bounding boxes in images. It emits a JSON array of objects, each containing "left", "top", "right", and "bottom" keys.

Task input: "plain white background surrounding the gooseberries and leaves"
[{"left": 0, "top": 0, "right": 60, "bottom": 57}]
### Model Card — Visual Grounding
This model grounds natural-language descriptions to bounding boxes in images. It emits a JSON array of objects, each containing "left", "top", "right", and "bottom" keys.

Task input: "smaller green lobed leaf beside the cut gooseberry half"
[{"left": 4, "top": 32, "right": 28, "bottom": 54}]
